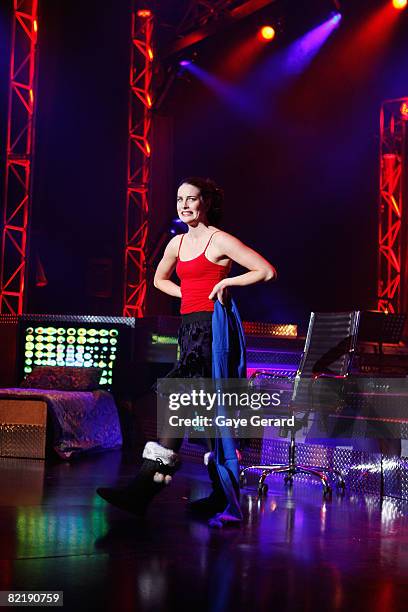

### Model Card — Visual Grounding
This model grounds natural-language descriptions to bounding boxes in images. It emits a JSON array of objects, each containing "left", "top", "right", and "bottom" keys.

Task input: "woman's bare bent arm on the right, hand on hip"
[{"left": 209, "top": 232, "right": 277, "bottom": 303}]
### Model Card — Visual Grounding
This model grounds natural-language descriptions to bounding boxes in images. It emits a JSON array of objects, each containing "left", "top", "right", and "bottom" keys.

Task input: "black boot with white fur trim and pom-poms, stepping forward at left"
[{"left": 96, "top": 442, "right": 181, "bottom": 516}]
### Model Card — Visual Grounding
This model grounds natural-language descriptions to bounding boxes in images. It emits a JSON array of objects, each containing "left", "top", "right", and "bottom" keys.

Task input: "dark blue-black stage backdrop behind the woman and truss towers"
[{"left": 0, "top": 0, "right": 408, "bottom": 325}]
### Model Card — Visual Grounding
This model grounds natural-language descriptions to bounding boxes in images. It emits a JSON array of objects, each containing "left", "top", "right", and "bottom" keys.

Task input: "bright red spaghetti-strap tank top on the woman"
[{"left": 176, "top": 230, "right": 227, "bottom": 314}]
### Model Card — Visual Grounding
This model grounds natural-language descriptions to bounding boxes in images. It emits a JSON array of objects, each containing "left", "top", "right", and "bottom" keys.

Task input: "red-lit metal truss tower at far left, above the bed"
[{"left": 0, "top": 0, "right": 38, "bottom": 314}]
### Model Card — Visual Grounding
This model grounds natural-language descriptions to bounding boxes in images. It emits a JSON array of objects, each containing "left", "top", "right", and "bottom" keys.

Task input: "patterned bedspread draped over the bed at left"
[{"left": 0, "top": 388, "right": 122, "bottom": 459}]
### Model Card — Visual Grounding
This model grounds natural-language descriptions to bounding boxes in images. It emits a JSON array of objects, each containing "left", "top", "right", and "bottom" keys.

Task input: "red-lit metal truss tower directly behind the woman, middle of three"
[{"left": 123, "top": 7, "right": 153, "bottom": 317}]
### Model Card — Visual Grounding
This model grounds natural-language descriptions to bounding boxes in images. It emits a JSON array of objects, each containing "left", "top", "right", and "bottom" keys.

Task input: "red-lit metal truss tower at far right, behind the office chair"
[{"left": 377, "top": 98, "right": 408, "bottom": 313}]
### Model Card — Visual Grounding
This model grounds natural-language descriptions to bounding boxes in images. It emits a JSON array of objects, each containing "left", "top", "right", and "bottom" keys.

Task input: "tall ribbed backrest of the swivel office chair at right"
[{"left": 292, "top": 311, "right": 360, "bottom": 405}]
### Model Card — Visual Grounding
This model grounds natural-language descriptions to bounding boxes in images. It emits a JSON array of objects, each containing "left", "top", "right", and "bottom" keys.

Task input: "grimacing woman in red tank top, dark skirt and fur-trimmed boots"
[{"left": 98, "top": 177, "right": 276, "bottom": 516}]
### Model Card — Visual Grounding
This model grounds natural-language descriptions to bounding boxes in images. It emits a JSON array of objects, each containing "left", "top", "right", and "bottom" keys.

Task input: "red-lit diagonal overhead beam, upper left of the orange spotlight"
[{"left": 164, "top": 0, "right": 276, "bottom": 57}]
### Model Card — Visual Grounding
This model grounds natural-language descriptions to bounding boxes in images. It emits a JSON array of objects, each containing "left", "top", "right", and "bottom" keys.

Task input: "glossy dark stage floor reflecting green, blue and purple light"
[{"left": 0, "top": 451, "right": 408, "bottom": 612}]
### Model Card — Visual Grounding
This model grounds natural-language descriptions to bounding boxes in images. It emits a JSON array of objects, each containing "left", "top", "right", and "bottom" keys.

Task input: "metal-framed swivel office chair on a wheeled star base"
[{"left": 240, "top": 311, "right": 360, "bottom": 496}]
